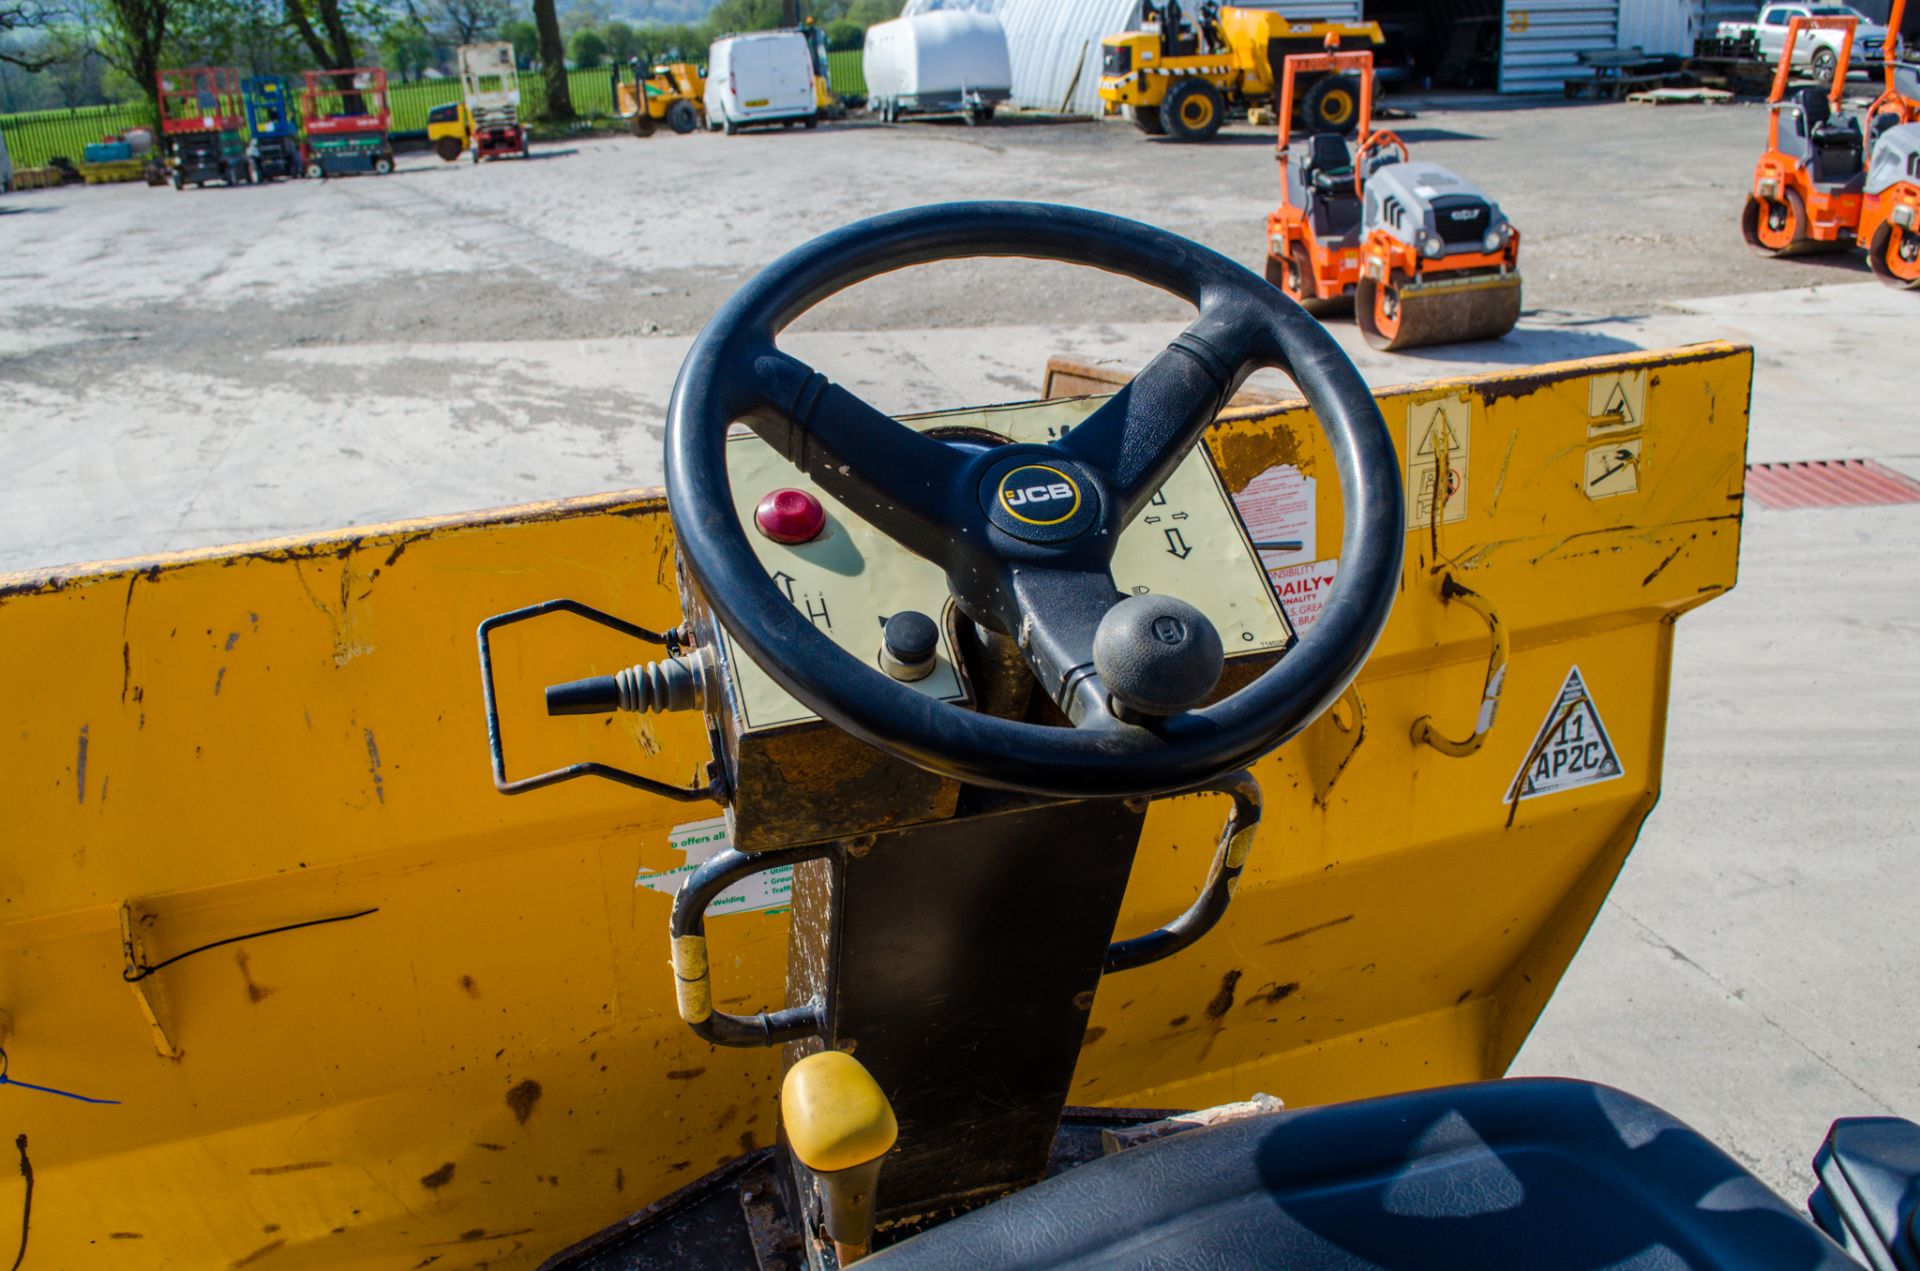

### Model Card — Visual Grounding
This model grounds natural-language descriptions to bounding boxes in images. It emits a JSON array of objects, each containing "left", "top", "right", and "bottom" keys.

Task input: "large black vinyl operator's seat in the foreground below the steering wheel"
[{"left": 864, "top": 1079, "right": 1859, "bottom": 1271}]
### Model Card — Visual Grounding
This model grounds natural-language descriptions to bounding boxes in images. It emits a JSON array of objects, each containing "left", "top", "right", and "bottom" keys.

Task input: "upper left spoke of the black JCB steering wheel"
[{"left": 739, "top": 344, "right": 968, "bottom": 566}]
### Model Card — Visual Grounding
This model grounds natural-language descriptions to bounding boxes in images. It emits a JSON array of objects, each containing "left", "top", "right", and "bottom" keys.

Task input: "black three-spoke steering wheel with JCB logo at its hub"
[{"left": 666, "top": 204, "right": 1405, "bottom": 799}]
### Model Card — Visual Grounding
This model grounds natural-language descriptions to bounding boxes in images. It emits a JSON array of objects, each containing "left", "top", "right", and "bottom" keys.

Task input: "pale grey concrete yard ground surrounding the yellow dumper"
[{"left": 0, "top": 104, "right": 1920, "bottom": 1200}]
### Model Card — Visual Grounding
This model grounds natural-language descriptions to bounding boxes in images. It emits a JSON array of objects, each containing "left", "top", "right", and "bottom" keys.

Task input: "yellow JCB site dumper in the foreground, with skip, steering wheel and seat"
[{"left": 0, "top": 204, "right": 1873, "bottom": 1271}]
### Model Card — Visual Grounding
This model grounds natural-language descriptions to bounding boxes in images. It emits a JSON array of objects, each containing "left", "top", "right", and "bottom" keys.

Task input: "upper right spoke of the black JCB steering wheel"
[{"left": 1056, "top": 309, "right": 1281, "bottom": 530}]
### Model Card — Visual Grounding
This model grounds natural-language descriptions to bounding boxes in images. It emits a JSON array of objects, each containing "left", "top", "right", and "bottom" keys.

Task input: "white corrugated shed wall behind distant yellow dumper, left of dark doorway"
[{"left": 991, "top": 0, "right": 1361, "bottom": 115}]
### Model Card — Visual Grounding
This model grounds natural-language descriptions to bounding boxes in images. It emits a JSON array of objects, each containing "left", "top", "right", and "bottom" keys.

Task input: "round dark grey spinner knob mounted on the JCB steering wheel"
[{"left": 1092, "top": 593, "right": 1227, "bottom": 716}]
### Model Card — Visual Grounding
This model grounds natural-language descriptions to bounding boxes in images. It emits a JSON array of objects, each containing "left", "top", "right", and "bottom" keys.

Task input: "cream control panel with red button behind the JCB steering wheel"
[{"left": 720, "top": 397, "right": 1294, "bottom": 731}]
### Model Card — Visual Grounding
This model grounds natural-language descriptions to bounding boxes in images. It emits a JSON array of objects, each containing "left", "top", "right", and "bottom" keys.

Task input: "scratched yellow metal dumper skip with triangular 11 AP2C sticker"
[{"left": 0, "top": 344, "right": 1751, "bottom": 1267}]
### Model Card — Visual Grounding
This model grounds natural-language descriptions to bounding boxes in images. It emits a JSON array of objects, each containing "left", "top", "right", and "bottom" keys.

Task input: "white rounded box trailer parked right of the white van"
[{"left": 862, "top": 10, "right": 1014, "bottom": 123}]
